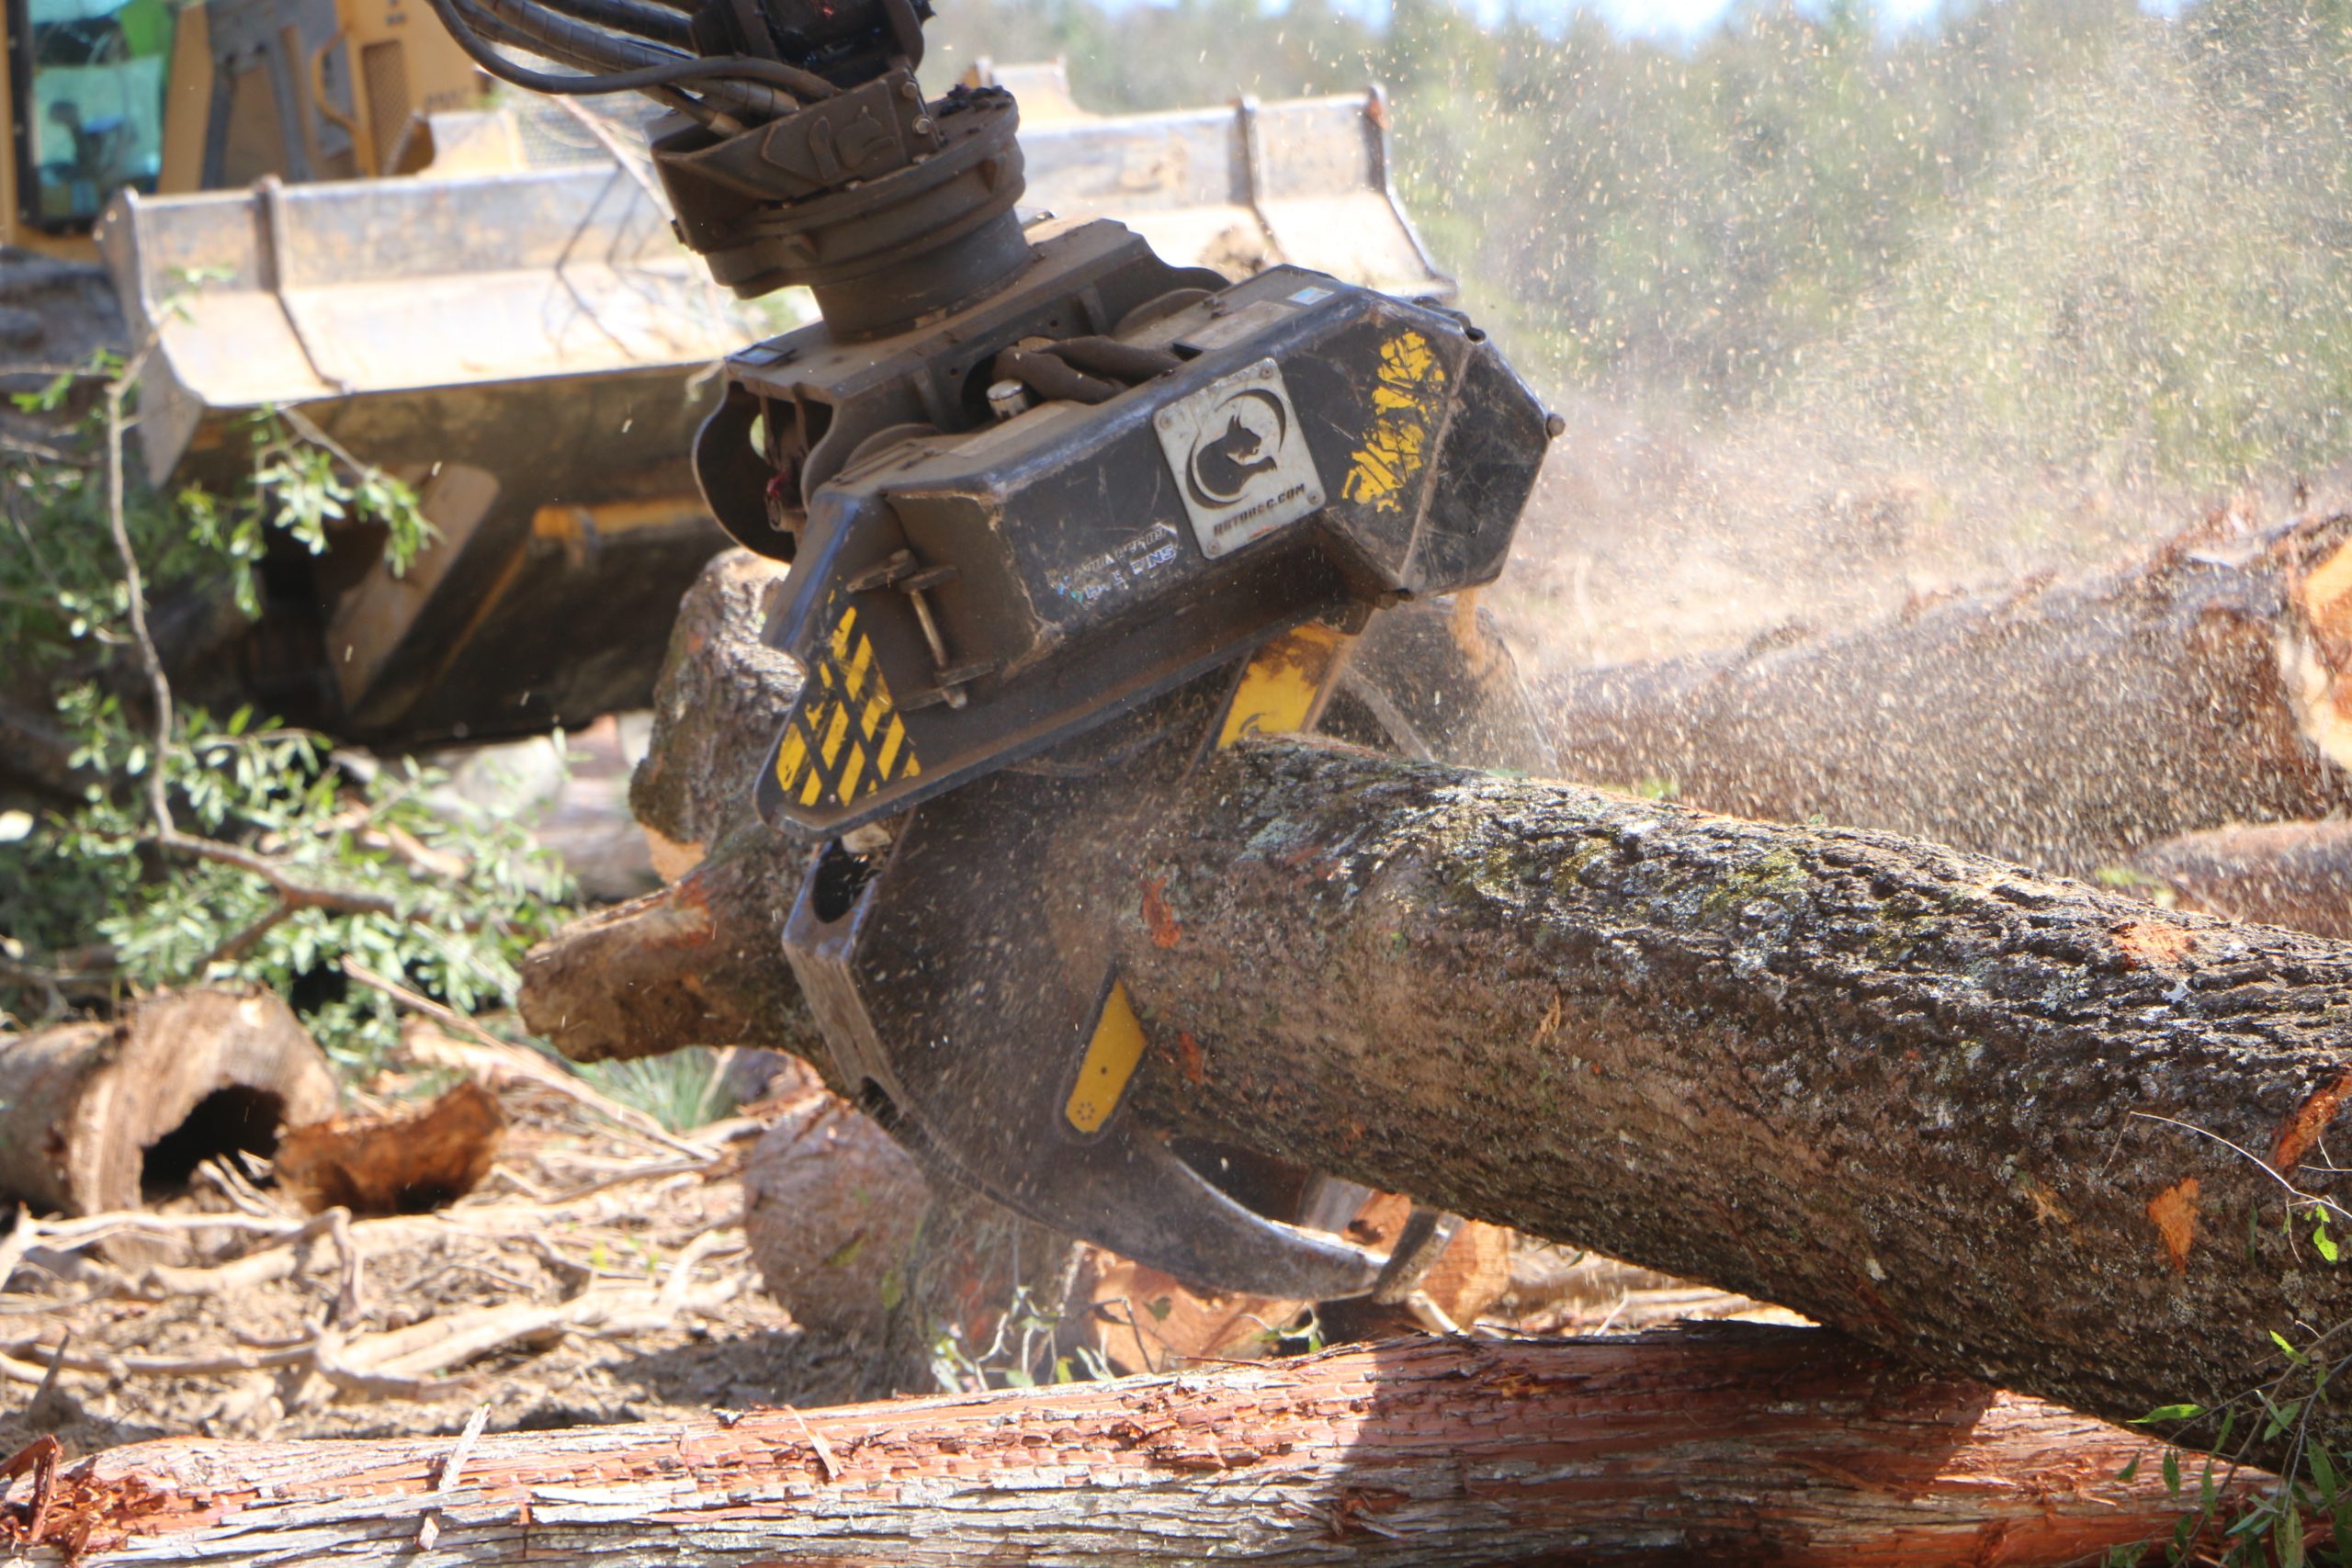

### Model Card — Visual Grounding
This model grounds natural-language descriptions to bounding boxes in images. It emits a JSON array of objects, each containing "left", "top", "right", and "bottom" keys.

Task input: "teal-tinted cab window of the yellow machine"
[{"left": 9, "top": 0, "right": 174, "bottom": 232}]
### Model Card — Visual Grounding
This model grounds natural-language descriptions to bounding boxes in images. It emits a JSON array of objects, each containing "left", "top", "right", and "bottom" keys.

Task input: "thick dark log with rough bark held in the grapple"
[{"left": 525, "top": 554, "right": 2352, "bottom": 1476}]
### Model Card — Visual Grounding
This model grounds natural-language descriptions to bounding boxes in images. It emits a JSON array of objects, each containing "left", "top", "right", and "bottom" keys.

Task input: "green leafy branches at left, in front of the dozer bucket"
[{"left": 0, "top": 360, "right": 564, "bottom": 1063}]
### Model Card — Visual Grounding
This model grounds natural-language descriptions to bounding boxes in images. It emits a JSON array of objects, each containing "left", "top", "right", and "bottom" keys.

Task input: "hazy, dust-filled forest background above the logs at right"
[{"left": 933, "top": 0, "right": 2352, "bottom": 668}]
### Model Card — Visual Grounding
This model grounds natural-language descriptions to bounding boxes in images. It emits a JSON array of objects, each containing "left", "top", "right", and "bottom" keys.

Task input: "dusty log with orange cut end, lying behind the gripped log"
[{"left": 1547, "top": 517, "right": 2352, "bottom": 874}]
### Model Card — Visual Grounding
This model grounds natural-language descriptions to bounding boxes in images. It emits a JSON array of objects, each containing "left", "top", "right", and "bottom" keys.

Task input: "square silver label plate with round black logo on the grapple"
[{"left": 1152, "top": 360, "right": 1324, "bottom": 559}]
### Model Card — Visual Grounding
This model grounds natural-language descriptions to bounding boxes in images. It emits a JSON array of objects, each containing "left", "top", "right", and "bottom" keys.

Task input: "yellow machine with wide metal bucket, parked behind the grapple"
[{"left": 0, "top": 0, "right": 1486, "bottom": 766}]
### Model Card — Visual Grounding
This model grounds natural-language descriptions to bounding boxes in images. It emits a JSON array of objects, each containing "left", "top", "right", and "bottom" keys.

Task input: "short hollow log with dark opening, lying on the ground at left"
[{"left": 0, "top": 989, "right": 336, "bottom": 1215}]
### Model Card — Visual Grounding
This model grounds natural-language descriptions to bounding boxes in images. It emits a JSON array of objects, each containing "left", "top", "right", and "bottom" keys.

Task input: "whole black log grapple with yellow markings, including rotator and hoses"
[{"left": 435, "top": 0, "right": 1557, "bottom": 1298}]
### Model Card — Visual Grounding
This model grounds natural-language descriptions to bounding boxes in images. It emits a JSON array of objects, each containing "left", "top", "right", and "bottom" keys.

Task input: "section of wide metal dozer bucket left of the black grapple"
[{"left": 99, "top": 163, "right": 774, "bottom": 740}]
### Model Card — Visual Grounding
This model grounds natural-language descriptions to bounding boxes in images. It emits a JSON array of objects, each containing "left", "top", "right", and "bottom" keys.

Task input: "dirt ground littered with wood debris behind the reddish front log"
[{"left": 0, "top": 1032, "right": 1797, "bottom": 1455}]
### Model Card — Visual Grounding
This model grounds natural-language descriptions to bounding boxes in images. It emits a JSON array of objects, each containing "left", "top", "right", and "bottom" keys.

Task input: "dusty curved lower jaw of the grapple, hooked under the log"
[{"left": 786, "top": 700, "right": 1385, "bottom": 1300}]
